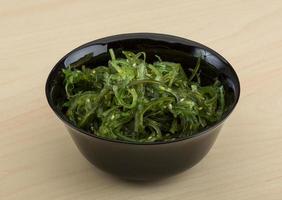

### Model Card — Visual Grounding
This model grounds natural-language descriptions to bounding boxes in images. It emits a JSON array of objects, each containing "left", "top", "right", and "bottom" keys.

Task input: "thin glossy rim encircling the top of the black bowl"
[{"left": 45, "top": 32, "right": 241, "bottom": 145}]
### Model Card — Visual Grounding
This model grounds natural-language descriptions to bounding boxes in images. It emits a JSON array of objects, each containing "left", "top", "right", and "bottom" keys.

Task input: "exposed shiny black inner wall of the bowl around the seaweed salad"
[{"left": 46, "top": 33, "right": 240, "bottom": 142}]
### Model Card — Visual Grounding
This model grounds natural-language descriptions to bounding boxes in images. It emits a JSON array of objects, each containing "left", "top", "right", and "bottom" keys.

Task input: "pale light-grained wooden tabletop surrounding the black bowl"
[{"left": 0, "top": 0, "right": 282, "bottom": 200}]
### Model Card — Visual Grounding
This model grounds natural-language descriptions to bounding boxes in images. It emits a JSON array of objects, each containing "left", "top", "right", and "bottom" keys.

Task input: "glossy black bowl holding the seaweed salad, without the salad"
[{"left": 46, "top": 33, "right": 240, "bottom": 180}]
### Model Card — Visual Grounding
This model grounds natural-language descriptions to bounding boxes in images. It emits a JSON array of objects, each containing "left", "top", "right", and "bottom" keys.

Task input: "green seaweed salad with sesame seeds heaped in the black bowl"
[{"left": 63, "top": 49, "right": 225, "bottom": 143}]
